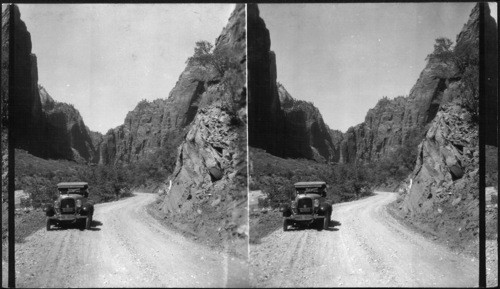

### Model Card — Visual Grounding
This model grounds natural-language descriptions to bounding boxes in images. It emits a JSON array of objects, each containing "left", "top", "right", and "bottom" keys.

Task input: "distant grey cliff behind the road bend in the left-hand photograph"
[{"left": 99, "top": 66, "right": 210, "bottom": 164}]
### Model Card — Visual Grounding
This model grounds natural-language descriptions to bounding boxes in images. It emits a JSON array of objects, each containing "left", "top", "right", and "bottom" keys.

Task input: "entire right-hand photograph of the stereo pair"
[{"left": 247, "top": 3, "right": 497, "bottom": 287}]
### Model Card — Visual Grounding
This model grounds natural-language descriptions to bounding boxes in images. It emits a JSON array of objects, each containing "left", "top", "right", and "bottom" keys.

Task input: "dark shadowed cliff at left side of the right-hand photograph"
[{"left": 247, "top": 4, "right": 339, "bottom": 162}]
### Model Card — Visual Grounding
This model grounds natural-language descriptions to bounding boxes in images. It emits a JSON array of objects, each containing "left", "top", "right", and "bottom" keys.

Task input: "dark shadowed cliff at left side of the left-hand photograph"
[{"left": 2, "top": 5, "right": 96, "bottom": 162}]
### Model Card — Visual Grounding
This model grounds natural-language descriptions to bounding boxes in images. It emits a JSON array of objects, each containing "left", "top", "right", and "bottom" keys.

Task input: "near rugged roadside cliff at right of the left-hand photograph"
[{"left": 150, "top": 4, "right": 248, "bottom": 255}]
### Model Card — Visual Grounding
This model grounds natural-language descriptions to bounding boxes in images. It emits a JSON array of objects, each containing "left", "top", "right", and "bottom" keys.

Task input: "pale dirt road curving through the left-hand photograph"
[{"left": 16, "top": 193, "right": 248, "bottom": 288}]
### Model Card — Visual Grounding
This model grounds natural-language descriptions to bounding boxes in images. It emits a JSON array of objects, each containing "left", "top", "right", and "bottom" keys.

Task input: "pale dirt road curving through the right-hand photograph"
[{"left": 250, "top": 192, "right": 479, "bottom": 287}]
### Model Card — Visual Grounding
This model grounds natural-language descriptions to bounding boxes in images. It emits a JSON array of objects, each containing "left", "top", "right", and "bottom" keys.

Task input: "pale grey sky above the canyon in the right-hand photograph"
[{"left": 259, "top": 3, "right": 496, "bottom": 132}]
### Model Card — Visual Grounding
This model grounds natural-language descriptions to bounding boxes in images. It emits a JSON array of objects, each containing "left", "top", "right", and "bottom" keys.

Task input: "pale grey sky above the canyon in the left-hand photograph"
[{"left": 18, "top": 4, "right": 234, "bottom": 133}]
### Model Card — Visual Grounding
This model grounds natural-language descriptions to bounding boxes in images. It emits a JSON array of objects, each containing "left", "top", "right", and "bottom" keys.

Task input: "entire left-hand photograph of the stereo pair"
[{"left": 2, "top": 4, "right": 249, "bottom": 288}]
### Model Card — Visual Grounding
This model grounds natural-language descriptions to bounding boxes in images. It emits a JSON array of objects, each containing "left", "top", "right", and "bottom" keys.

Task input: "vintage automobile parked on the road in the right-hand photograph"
[{"left": 280, "top": 182, "right": 332, "bottom": 231}]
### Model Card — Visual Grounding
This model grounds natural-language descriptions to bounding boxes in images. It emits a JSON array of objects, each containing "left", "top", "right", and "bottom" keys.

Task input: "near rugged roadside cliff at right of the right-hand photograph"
[{"left": 399, "top": 4, "right": 496, "bottom": 250}]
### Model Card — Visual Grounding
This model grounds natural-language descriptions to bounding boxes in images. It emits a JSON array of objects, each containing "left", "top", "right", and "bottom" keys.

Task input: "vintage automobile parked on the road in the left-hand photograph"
[{"left": 45, "top": 182, "right": 94, "bottom": 231}]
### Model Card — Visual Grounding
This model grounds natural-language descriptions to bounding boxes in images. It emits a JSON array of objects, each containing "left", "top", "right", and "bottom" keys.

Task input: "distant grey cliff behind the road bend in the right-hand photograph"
[{"left": 341, "top": 48, "right": 457, "bottom": 163}]
